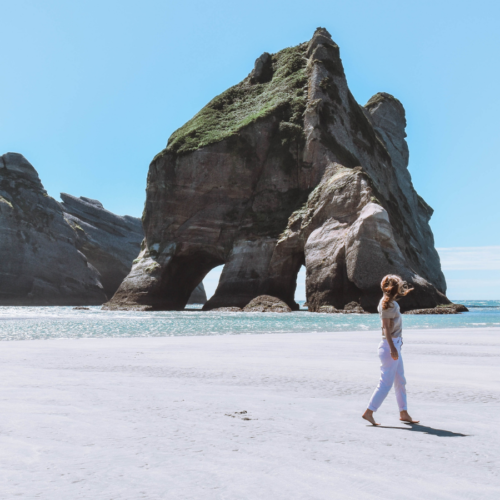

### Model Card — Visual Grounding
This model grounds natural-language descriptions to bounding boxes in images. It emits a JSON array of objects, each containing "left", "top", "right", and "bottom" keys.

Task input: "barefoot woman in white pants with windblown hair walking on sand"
[{"left": 363, "top": 274, "right": 418, "bottom": 425}]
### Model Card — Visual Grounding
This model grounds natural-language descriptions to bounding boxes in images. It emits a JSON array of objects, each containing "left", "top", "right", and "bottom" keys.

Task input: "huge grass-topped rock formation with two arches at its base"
[{"left": 107, "top": 28, "right": 449, "bottom": 311}]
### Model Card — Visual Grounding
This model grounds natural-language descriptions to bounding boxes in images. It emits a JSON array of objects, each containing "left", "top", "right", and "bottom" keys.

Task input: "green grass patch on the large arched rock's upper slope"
[{"left": 160, "top": 44, "right": 307, "bottom": 155}]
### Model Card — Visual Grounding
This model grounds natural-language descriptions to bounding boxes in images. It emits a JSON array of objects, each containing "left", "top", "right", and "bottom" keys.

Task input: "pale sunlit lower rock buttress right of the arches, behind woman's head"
[{"left": 278, "top": 163, "right": 449, "bottom": 312}]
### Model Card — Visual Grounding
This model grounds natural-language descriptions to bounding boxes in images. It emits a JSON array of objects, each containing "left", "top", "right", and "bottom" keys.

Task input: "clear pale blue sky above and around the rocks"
[{"left": 0, "top": 0, "right": 500, "bottom": 298}]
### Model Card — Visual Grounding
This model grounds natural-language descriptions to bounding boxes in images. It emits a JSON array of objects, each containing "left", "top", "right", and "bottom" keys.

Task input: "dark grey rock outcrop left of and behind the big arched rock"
[{"left": 0, "top": 153, "right": 207, "bottom": 305}]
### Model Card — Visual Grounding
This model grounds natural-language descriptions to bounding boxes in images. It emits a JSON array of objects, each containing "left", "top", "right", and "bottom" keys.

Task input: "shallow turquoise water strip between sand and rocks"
[{"left": 0, "top": 300, "right": 500, "bottom": 340}]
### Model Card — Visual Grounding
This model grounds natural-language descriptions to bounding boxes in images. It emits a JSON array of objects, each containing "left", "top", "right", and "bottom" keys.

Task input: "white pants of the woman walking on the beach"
[{"left": 368, "top": 337, "right": 408, "bottom": 411}]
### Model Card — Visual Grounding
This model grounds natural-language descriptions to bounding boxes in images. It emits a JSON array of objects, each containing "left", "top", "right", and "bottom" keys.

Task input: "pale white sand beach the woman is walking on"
[{"left": 0, "top": 329, "right": 500, "bottom": 500}]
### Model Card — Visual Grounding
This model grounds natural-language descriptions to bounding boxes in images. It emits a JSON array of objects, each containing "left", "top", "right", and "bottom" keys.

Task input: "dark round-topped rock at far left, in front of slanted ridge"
[{"left": 0, "top": 153, "right": 106, "bottom": 305}]
